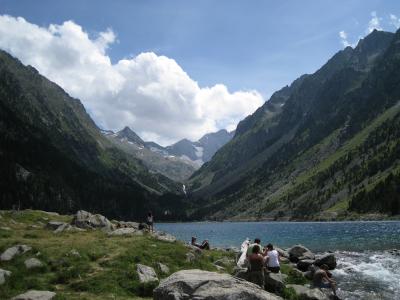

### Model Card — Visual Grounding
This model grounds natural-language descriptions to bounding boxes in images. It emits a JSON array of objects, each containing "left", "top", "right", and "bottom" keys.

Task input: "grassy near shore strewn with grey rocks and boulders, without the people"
[{"left": 0, "top": 211, "right": 342, "bottom": 300}]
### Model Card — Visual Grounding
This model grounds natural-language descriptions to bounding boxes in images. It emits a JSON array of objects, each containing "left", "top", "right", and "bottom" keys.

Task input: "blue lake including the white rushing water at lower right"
[{"left": 155, "top": 221, "right": 400, "bottom": 300}]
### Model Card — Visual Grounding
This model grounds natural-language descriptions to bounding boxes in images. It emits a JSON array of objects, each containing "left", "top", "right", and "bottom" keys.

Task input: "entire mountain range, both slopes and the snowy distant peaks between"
[{"left": 0, "top": 30, "right": 400, "bottom": 220}]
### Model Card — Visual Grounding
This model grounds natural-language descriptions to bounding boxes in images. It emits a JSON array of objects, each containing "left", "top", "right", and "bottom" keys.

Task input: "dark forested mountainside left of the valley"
[{"left": 0, "top": 51, "right": 185, "bottom": 218}]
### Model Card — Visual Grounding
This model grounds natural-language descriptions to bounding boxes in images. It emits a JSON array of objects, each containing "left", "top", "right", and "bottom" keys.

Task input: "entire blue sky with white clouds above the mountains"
[{"left": 0, "top": 0, "right": 400, "bottom": 145}]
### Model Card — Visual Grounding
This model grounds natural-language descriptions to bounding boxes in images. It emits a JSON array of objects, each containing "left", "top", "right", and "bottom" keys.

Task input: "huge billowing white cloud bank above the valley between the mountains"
[{"left": 0, "top": 15, "right": 264, "bottom": 145}]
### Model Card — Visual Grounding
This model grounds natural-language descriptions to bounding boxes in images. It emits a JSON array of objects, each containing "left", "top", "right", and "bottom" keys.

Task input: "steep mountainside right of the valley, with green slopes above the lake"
[{"left": 189, "top": 30, "right": 400, "bottom": 220}]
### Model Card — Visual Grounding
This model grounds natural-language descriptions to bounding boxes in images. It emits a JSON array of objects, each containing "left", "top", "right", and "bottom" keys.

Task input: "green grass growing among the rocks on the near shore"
[{"left": 0, "top": 211, "right": 234, "bottom": 299}]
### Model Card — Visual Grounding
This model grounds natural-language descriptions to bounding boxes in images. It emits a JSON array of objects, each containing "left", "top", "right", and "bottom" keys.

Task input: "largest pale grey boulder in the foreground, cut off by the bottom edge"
[{"left": 153, "top": 270, "right": 282, "bottom": 300}]
